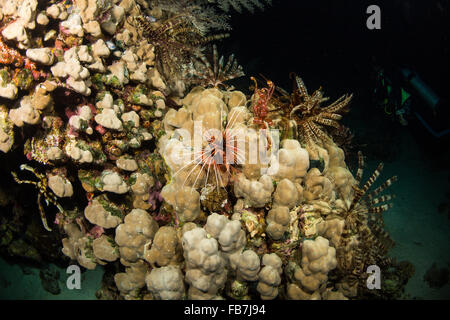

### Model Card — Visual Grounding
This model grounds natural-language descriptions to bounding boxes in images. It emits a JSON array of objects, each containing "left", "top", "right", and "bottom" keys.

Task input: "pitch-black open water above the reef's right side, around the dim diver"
[{"left": 220, "top": 0, "right": 450, "bottom": 165}]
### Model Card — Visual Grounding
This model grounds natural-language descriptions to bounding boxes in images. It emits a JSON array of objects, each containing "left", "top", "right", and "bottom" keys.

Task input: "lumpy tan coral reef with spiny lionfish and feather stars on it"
[{"left": 0, "top": 0, "right": 412, "bottom": 300}]
